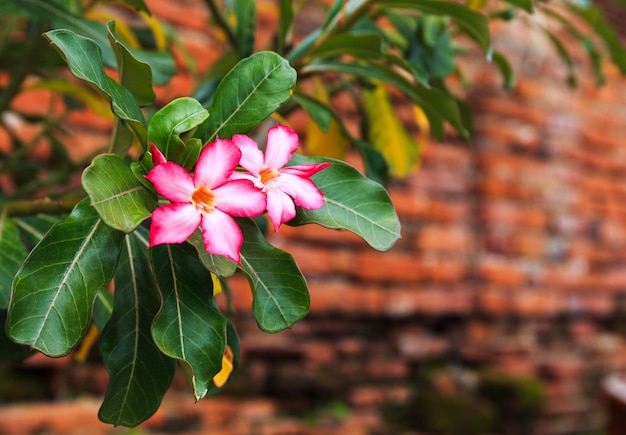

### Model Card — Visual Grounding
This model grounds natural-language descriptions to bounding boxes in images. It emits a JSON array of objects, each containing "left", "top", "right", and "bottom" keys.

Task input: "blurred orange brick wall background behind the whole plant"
[{"left": 0, "top": 0, "right": 626, "bottom": 435}]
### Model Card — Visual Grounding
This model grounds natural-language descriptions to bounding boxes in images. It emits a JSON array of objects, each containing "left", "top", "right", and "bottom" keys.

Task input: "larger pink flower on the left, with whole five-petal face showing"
[{"left": 146, "top": 139, "right": 266, "bottom": 263}]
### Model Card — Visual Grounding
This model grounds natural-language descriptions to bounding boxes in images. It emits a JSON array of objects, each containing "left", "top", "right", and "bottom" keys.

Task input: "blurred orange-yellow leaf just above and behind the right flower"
[{"left": 306, "top": 78, "right": 350, "bottom": 159}]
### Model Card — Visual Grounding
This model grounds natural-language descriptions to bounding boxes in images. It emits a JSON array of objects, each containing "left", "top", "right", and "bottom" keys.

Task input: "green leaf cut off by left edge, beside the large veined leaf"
[{"left": 0, "top": 210, "right": 28, "bottom": 309}]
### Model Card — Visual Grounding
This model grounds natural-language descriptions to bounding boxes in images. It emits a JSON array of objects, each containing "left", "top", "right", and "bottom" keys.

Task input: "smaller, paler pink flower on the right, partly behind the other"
[{"left": 232, "top": 125, "right": 330, "bottom": 231}]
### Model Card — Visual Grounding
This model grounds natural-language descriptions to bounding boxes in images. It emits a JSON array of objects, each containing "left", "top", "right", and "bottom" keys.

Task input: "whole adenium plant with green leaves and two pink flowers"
[{"left": 0, "top": 0, "right": 626, "bottom": 426}]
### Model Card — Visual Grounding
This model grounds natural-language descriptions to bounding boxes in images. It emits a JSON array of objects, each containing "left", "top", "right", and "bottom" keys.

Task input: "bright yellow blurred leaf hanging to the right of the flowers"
[{"left": 363, "top": 83, "right": 419, "bottom": 178}]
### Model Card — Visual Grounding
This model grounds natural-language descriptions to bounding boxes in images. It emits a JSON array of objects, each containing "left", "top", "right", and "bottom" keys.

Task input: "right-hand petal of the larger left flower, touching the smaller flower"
[{"left": 213, "top": 180, "right": 266, "bottom": 217}]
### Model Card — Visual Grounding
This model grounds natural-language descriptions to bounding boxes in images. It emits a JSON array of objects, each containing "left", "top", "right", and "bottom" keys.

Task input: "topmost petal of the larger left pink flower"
[{"left": 193, "top": 139, "right": 241, "bottom": 189}]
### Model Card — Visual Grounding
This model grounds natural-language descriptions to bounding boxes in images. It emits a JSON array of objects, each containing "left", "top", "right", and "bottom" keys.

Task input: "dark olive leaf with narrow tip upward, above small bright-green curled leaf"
[{"left": 107, "top": 21, "right": 156, "bottom": 106}]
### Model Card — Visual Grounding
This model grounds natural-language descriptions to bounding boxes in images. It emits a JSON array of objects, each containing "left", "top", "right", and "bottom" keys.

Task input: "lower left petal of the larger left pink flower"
[{"left": 148, "top": 204, "right": 201, "bottom": 248}]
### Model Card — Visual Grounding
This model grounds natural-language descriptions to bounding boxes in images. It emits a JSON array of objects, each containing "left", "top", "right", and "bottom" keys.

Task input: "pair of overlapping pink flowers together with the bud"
[{"left": 146, "top": 126, "right": 330, "bottom": 263}]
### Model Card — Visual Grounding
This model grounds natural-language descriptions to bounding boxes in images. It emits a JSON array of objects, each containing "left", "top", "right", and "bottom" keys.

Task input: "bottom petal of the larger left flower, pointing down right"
[{"left": 200, "top": 210, "right": 243, "bottom": 263}]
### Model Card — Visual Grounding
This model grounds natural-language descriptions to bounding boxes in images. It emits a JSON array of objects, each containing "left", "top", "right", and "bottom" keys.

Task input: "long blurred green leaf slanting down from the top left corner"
[{"left": 8, "top": 0, "right": 116, "bottom": 67}]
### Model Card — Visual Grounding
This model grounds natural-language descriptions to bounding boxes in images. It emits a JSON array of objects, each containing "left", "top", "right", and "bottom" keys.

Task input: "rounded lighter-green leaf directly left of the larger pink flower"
[{"left": 82, "top": 154, "right": 156, "bottom": 233}]
